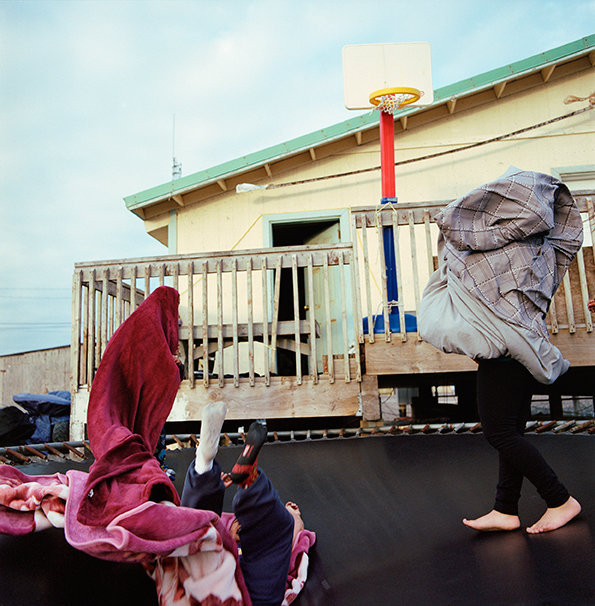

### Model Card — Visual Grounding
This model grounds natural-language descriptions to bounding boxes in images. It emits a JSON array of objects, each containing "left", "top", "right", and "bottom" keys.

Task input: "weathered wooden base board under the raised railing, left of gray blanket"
[{"left": 365, "top": 340, "right": 477, "bottom": 375}]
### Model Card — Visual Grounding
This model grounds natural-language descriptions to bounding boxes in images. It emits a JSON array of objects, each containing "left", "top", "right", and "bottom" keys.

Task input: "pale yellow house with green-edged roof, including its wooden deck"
[{"left": 71, "top": 35, "right": 595, "bottom": 439}]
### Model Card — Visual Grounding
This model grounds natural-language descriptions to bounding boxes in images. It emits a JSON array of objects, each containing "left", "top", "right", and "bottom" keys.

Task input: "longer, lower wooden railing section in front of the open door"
[{"left": 71, "top": 244, "right": 361, "bottom": 391}]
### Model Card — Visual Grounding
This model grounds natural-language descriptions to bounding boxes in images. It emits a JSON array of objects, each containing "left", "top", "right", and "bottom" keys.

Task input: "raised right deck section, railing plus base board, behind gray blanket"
[{"left": 351, "top": 191, "right": 595, "bottom": 374}]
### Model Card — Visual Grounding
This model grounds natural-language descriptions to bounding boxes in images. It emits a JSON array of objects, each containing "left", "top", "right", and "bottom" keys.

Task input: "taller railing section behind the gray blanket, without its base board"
[{"left": 351, "top": 193, "right": 595, "bottom": 343}]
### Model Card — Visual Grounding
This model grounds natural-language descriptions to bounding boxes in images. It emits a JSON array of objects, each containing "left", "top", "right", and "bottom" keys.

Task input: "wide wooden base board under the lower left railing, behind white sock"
[{"left": 168, "top": 375, "right": 360, "bottom": 421}]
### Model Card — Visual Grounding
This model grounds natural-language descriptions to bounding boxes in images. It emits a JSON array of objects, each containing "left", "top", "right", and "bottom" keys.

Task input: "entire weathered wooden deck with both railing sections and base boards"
[{"left": 71, "top": 197, "right": 595, "bottom": 439}]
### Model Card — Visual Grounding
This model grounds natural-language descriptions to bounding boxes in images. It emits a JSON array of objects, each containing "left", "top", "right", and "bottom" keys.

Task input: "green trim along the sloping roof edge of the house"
[{"left": 124, "top": 34, "right": 595, "bottom": 211}]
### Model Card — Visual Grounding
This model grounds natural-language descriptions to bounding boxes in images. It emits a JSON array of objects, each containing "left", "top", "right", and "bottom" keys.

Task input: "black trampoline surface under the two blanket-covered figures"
[{"left": 0, "top": 433, "right": 595, "bottom": 606}]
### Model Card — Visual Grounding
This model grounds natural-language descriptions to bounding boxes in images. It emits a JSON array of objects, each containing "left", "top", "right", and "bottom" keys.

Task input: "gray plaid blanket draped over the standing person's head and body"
[{"left": 419, "top": 167, "right": 583, "bottom": 383}]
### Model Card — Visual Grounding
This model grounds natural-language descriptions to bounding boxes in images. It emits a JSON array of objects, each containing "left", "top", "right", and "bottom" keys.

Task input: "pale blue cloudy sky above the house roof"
[{"left": 0, "top": 0, "right": 595, "bottom": 355}]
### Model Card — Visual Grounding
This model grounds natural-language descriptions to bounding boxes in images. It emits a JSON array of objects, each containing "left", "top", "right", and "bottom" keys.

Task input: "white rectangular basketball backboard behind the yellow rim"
[{"left": 343, "top": 42, "right": 434, "bottom": 109}]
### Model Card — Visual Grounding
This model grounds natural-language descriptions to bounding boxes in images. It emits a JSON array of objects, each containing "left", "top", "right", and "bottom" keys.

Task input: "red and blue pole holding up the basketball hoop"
[{"left": 380, "top": 110, "right": 404, "bottom": 314}]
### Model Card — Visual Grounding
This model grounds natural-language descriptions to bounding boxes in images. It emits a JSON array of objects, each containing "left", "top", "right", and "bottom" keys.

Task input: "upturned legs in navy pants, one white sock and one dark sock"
[{"left": 181, "top": 402, "right": 304, "bottom": 606}]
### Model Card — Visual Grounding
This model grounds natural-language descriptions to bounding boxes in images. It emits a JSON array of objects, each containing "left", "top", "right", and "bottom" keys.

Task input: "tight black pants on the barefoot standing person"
[{"left": 477, "top": 358, "right": 570, "bottom": 515}]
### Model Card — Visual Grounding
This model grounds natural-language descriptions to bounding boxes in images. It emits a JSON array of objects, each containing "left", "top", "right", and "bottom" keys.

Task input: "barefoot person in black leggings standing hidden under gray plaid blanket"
[{"left": 419, "top": 167, "right": 583, "bottom": 534}]
